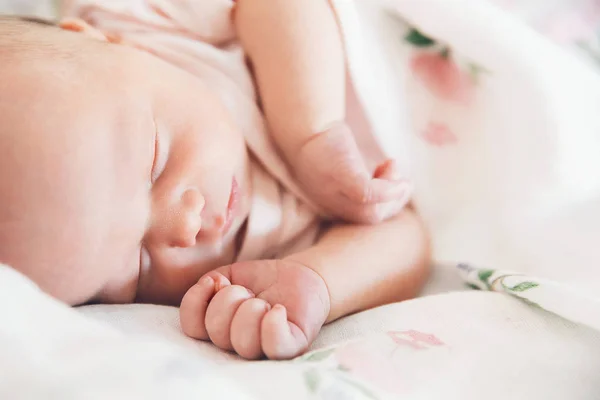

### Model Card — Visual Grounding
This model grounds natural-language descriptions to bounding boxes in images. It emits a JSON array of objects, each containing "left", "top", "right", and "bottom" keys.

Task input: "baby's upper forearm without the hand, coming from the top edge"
[{"left": 234, "top": 0, "right": 346, "bottom": 158}]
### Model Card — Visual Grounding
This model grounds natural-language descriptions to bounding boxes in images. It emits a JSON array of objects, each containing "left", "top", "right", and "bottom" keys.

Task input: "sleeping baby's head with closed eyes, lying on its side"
[{"left": 0, "top": 19, "right": 248, "bottom": 303}]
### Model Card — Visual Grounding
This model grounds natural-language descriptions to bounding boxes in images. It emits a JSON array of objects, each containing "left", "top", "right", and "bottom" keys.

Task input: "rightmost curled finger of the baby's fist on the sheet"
[{"left": 260, "top": 305, "right": 308, "bottom": 360}]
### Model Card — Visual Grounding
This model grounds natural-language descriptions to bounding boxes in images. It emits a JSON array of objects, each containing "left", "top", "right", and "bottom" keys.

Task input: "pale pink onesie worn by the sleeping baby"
[{"left": 63, "top": 0, "right": 396, "bottom": 261}]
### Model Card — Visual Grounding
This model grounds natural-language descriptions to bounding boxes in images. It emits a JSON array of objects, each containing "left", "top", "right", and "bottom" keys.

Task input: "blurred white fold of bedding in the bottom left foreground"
[{"left": 0, "top": 265, "right": 247, "bottom": 400}]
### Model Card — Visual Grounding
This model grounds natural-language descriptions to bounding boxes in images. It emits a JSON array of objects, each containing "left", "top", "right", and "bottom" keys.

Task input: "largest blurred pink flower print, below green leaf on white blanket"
[{"left": 410, "top": 50, "right": 475, "bottom": 104}]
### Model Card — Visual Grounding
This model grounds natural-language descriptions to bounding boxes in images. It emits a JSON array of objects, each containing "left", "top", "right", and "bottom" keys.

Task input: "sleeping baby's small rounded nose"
[{"left": 167, "top": 188, "right": 205, "bottom": 247}]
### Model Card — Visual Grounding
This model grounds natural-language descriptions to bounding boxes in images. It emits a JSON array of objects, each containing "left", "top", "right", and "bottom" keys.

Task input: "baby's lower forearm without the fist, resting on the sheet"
[{"left": 287, "top": 210, "right": 429, "bottom": 322}]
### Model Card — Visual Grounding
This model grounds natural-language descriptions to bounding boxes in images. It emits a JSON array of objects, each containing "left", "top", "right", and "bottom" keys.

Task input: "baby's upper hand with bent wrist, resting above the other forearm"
[{"left": 288, "top": 123, "right": 411, "bottom": 224}]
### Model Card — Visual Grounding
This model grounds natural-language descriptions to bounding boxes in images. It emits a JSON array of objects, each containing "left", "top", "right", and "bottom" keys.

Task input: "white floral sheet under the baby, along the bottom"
[{"left": 0, "top": 0, "right": 600, "bottom": 400}]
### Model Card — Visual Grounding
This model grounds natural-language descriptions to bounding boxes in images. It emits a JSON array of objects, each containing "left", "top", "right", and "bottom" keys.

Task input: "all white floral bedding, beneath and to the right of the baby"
[{"left": 0, "top": 0, "right": 600, "bottom": 400}]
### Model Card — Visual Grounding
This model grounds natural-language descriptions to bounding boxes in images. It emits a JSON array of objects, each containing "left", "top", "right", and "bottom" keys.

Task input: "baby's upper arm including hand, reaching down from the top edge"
[{"left": 234, "top": 0, "right": 409, "bottom": 223}]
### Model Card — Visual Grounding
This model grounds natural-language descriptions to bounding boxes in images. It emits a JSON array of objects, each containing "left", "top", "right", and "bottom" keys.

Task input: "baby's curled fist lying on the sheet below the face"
[{"left": 180, "top": 260, "right": 330, "bottom": 360}]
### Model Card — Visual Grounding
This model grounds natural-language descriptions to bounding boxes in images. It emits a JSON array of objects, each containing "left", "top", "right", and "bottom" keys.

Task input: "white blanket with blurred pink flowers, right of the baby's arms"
[{"left": 357, "top": 0, "right": 600, "bottom": 293}]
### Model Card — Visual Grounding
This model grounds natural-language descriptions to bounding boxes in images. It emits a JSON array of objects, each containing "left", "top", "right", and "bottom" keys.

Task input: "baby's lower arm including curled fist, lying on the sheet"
[{"left": 180, "top": 209, "right": 429, "bottom": 359}]
